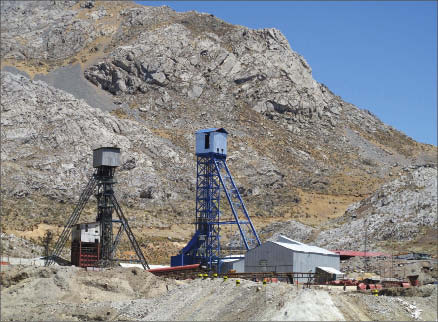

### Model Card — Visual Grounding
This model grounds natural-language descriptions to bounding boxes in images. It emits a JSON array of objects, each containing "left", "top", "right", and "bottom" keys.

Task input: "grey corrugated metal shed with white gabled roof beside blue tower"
[{"left": 245, "top": 236, "right": 340, "bottom": 273}]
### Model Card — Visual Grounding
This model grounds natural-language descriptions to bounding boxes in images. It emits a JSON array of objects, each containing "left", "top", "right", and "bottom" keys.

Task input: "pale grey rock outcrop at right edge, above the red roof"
[{"left": 314, "top": 165, "right": 438, "bottom": 251}]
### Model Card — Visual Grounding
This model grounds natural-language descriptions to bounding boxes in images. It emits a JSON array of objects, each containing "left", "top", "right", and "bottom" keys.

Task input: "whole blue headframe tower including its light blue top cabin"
[{"left": 171, "top": 128, "right": 260, "bottom": 270}]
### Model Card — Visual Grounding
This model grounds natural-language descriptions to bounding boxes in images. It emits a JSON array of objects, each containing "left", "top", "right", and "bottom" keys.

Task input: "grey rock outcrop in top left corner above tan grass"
[{"left": 0, "top": 1, "right": 96, "bottom": 64}]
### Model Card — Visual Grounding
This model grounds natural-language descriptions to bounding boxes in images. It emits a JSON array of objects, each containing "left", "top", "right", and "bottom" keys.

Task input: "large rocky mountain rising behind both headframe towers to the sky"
[{"left": 0, "top": 1, "right": 437, "bottom": 262}]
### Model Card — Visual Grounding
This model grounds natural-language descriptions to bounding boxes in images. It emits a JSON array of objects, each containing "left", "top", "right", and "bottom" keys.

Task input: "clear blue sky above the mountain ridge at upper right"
[{"left": 137, "top": 1, "right": 437, "bottom": 145}]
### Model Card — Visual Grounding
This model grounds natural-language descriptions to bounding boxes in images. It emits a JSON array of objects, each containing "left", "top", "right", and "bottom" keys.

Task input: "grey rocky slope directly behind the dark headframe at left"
[{"left": 1, "top": 72, "right": 193, "bottom": 207}]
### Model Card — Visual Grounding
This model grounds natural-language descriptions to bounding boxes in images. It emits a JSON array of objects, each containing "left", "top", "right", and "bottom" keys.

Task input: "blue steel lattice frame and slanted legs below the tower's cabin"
[{"left": 175, "top": 148, "right": 260, "bottom": 267}]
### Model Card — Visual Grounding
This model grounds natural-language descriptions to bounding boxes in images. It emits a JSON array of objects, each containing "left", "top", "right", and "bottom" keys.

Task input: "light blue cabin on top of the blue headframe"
[{"left": 196, "top": 128, "right": 228, "bottom": 157}]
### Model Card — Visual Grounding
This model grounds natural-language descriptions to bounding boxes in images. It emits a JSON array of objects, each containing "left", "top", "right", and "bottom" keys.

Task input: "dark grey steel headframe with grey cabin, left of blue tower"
[{"left": 46, "top": 147, "right": 149, "bottom": 269}]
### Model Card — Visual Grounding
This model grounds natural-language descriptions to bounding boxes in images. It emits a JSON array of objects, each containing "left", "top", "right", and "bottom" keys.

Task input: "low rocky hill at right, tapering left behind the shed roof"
[{"left": 261, "top": 165, "right": 438, "bottom": 254}]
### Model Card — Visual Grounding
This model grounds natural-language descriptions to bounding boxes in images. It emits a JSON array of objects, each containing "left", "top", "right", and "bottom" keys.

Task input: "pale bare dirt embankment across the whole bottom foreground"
[{"left": 1, "top": 266, "right": 437, "bottom": 321}]
